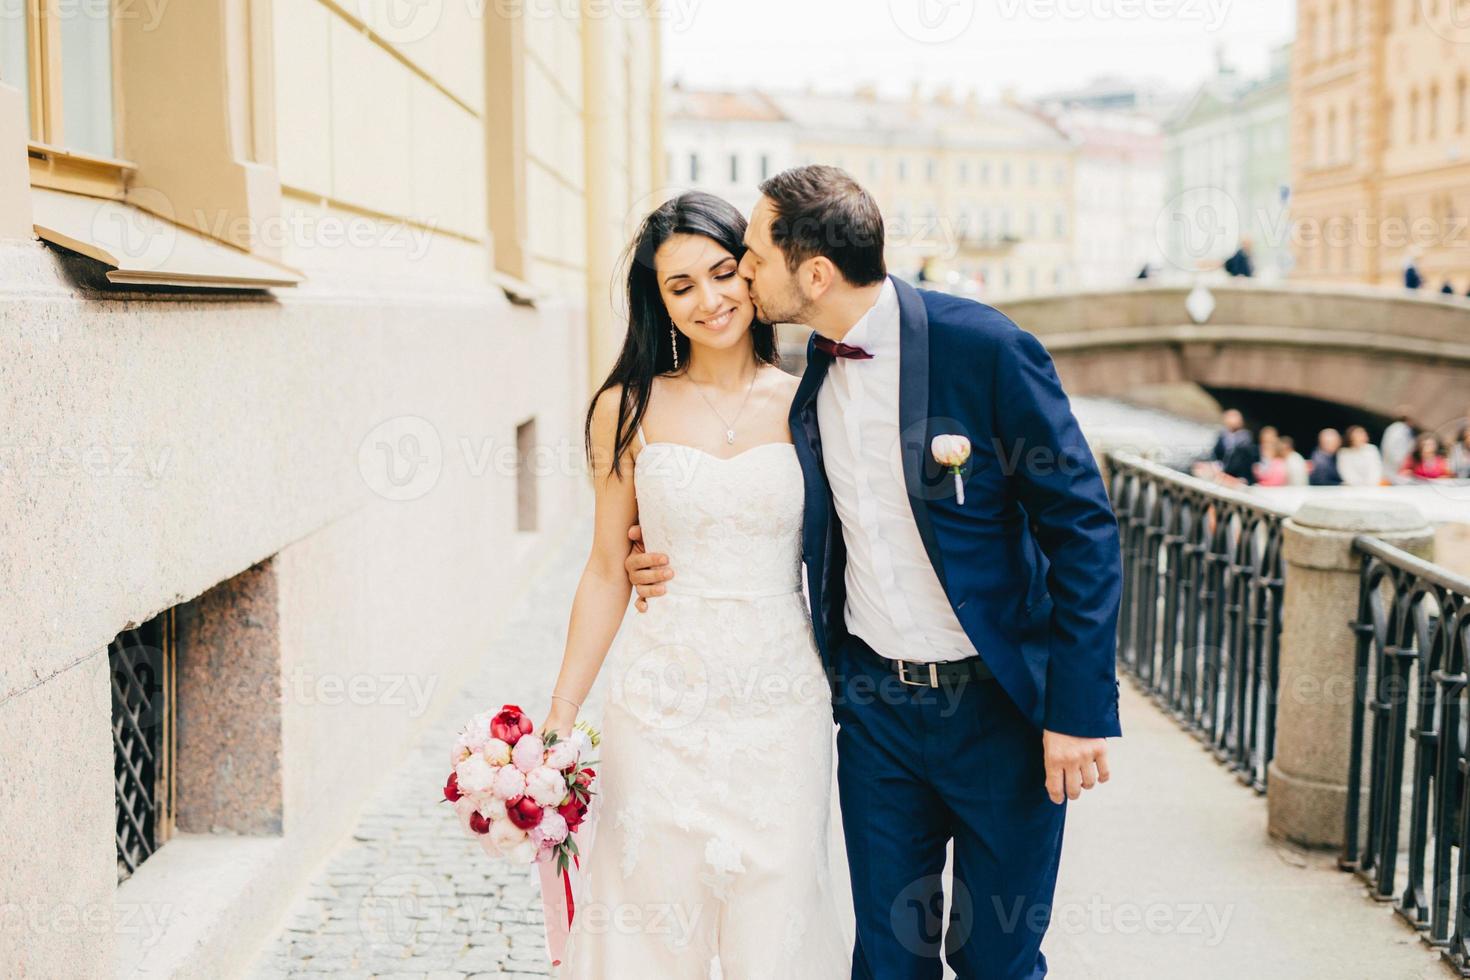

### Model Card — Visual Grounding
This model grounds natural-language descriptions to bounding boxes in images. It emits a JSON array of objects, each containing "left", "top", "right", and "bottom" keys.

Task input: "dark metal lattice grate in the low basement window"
[{"left": 107, "top": 610, "right": 175, "bottom": 882}]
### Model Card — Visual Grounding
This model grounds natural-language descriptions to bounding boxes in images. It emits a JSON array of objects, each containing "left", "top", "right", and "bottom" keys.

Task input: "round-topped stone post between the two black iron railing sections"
[{"left": 1266, "top": 497, "right": 1435, "bottom": 848}]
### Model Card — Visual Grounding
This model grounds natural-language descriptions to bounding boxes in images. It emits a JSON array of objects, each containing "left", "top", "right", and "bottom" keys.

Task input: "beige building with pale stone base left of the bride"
[{"left": 0, "top": 0, "right": 663, "bottom": 977}]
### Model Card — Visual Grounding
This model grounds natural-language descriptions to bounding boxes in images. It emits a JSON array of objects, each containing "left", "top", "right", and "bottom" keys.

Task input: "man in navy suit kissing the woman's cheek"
[{"left": 628, "top": 166, "right": 1122, "bottom": 980}]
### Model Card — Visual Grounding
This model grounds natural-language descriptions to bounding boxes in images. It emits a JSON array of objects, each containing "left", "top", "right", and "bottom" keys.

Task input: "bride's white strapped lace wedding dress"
[{"left": 560, "top": 426, "right": 851, "bottom": 980}]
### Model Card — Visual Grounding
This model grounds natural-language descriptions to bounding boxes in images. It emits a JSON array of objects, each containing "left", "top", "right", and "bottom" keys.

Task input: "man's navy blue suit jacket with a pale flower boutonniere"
[{"left": 791, "top": 279, "right": 1123, "bottom": 738}]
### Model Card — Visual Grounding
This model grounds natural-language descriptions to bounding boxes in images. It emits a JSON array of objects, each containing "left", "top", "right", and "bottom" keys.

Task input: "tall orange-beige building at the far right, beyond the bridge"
[{"left": 1292, "top": 0, "right": 1470, "bottom": 294}]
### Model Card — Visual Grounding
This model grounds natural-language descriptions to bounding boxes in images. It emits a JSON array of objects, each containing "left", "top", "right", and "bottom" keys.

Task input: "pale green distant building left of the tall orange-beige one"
[{"left": 1158, "top": 47, "right": 1292, "bottom": 279}]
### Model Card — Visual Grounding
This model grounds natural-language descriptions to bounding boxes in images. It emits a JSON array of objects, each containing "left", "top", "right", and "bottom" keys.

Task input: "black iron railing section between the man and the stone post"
[{"left": 1107, "top": 453, "right": 1288, "bottom": 792}]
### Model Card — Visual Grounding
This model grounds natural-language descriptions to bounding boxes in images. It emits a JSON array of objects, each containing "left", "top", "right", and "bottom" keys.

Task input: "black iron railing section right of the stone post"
[{"left": 1342, "top": 536, "right": 1470, "bottom": 976}]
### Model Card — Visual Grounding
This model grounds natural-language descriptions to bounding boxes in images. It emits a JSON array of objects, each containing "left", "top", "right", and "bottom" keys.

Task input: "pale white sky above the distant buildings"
[{"left": 659, "top": 0, "right": 1297, "bottom": 97}]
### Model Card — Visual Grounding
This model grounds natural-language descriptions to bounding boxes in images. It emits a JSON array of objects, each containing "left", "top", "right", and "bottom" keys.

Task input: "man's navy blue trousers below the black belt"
[{"left": 832, "top": 636, "right": 1066, "bottom": 980}]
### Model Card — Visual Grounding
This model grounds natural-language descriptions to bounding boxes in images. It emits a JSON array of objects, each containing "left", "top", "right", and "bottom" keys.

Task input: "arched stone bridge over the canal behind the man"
[{"left": 995, "top": 281, "right": 1470, "bottom": 435}]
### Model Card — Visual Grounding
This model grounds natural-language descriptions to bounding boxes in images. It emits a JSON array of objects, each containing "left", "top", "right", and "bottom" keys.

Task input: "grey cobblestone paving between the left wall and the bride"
[{"left": 247, "top": 520, "right": 600, "bottom": 980}]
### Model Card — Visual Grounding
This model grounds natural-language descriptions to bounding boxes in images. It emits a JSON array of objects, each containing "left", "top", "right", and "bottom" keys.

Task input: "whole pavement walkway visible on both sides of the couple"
[{"left": 248, "top": 522, "right": 1452, "bottom": 980}]
